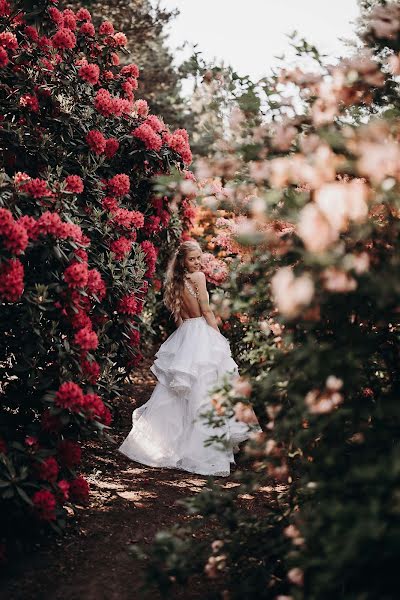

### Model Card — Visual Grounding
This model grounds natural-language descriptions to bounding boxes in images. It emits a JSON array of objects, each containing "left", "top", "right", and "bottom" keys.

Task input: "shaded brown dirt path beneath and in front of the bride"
[{"left": 0, "top": 365, "right": 276, "bottom": 600}]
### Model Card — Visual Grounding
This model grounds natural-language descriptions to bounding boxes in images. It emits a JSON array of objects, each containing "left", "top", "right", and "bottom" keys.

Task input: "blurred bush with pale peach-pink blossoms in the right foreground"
[{"left": 140, "top": 3, "right": 400, "bottom": 600}]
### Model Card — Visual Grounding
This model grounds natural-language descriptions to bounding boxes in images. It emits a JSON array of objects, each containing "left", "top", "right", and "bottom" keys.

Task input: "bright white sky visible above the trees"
[{"left": 161, "top": 0, "right": 358, "bottom": 78}]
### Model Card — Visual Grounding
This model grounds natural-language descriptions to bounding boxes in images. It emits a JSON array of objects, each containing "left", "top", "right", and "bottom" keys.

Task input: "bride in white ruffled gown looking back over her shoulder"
[{"left": 119, "top": 241, "right": 260, "bottom": 476}]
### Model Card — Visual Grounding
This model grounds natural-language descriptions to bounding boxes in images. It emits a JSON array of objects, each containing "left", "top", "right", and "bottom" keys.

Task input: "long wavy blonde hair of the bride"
[{"left": 164, "top": 240, "right": 201, "bottom": 321}]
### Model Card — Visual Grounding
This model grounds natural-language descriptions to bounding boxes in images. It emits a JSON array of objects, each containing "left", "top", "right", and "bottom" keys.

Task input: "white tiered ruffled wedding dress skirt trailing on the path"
[{"left": 119, "top": 317, "right": 255, "bottom": 477}]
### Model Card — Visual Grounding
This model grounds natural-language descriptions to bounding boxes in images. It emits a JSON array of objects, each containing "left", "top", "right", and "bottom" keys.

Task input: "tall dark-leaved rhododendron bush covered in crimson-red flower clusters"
[{"left": 0, "top": 0, "right": 191, "bottom": 541}]
